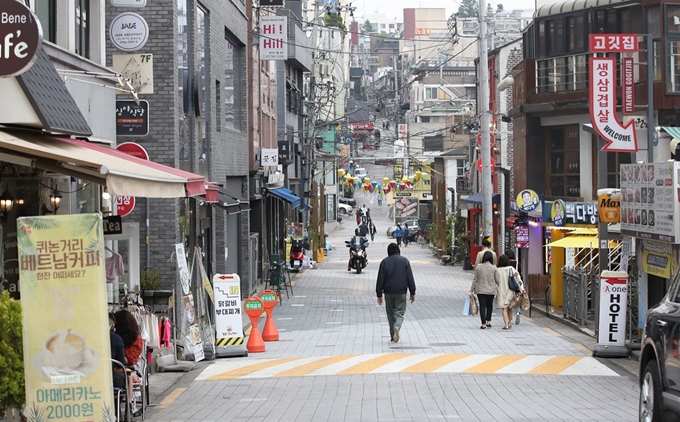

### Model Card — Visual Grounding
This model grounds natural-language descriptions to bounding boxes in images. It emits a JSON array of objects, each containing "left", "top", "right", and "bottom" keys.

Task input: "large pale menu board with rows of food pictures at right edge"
[{"left": 620, "top": 162, "right": 680, "bottom": 243}]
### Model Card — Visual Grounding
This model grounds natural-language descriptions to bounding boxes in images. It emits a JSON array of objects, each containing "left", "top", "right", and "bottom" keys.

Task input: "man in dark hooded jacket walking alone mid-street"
[{"left": 375, "top": 243, "right": 416, "bottom": 343}]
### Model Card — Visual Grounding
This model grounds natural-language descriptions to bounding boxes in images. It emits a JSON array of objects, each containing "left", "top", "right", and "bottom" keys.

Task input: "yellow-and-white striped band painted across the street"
[{"left": 197, "top": 353, "right": 619, "bottom": 381}]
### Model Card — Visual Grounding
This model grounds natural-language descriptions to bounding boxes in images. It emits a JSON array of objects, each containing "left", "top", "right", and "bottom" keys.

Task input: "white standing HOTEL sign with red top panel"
[{"left": 597, "top": 271, "right": 628, "bottom": 348}]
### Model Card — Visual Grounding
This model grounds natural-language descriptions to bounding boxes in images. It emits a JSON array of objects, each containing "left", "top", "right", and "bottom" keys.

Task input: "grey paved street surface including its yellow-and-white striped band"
[{"left": 150, "top": 179, "right": 638, "bottom": 422}]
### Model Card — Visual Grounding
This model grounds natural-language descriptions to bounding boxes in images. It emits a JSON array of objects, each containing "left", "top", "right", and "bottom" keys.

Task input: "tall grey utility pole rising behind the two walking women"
[{"left": 478, "top": 0, "right": 493, "bottom": 236}]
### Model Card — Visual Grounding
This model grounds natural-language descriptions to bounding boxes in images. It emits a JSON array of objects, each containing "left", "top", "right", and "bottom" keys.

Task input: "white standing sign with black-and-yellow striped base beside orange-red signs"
[{"left": 213, "top": 274, "right": 245, "bottom": 347}]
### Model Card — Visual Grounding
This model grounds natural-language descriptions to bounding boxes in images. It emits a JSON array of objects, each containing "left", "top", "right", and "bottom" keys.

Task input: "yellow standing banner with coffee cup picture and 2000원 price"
[{"left": 17, "top": 214, "right": 115, "bottom": 422}]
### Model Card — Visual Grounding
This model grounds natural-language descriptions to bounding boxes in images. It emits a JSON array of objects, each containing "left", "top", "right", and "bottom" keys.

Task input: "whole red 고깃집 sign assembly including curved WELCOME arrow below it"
[{"left": 589, "top": 34, "right": 638, "bottom": 152}]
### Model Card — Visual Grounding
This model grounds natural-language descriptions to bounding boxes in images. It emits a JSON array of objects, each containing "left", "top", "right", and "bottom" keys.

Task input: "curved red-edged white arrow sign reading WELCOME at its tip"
[{"left": 590, "top": 57, "right": 638, "bottom": 152}]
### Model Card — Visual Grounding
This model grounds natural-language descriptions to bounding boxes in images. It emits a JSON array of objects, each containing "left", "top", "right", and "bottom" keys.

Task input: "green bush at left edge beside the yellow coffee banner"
[{"left": 0, "top": 291, "right": 25, "bottom": 416}]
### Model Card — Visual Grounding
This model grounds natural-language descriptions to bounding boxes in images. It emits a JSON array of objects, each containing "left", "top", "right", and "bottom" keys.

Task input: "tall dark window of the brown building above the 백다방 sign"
[{"left": 546, "top": 125, "right": 581, "bottom": 198}]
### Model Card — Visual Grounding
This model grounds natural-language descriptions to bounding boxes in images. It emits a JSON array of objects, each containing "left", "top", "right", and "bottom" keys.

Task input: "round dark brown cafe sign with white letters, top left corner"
[{"left": 0, "top": 0, "right": 42, "bottom": 78}]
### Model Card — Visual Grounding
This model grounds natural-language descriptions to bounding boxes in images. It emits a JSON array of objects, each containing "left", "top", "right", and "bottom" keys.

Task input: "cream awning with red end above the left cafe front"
[{"left": 0, "top": 129, "right": 206, "bottom": 198}]
